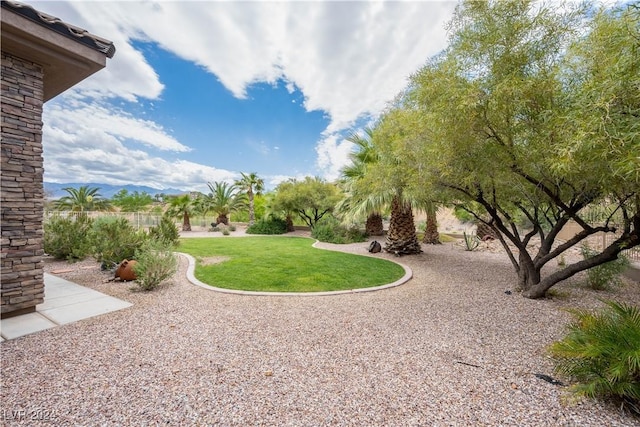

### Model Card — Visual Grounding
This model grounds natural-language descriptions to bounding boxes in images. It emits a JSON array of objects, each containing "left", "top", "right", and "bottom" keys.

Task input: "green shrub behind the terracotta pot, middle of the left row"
[{"left": 92, "top": 216, "right": 148, "bottom": 267}]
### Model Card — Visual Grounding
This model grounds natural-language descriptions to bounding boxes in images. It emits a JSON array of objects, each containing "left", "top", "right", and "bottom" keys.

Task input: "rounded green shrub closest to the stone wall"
[{"left": 44, "top": 215, "right": 93, "bottom": 261}]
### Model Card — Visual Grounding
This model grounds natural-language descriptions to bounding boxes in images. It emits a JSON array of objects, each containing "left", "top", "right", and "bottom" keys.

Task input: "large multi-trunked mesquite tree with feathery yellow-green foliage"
[{"left": 396, "top": 0, "right": 640, "bottom": 298}]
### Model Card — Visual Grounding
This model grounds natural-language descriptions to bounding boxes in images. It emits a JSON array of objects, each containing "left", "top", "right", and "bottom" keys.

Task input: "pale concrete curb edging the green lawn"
[{"left": 176, "top": 240, "right": 413, "bottom": 297}]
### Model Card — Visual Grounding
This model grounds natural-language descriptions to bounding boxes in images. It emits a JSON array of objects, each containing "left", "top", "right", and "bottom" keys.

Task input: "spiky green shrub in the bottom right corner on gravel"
[{"left": 549, "top": 301, "right": 640, "bottom": 413}]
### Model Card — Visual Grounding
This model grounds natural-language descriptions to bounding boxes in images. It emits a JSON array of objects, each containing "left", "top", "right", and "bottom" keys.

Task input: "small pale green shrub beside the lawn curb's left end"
[{"left": 133, "top": 239, "right": 178, "bottom": 291}]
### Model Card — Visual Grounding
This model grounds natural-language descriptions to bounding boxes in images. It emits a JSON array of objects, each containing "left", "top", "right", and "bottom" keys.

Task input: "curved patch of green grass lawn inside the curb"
[{"left": 178, "top": 237, "right": 404, "bottom": 292}]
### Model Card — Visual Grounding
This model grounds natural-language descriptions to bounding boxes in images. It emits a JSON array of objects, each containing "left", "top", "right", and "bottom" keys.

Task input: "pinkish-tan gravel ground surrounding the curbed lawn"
[{"left": 0, "top": 236, "right": 640, "bottom": 426}]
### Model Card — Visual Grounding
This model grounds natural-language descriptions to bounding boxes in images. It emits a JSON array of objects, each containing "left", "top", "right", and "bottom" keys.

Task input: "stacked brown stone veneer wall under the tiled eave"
[{"left": 0, "top": 52, "right": 44, "bottom": 318}]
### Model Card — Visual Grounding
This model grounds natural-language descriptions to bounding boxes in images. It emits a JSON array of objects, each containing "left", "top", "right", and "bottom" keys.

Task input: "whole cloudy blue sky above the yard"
[{"left": 29, "top": 1, "right": 456, "bottom": 191}]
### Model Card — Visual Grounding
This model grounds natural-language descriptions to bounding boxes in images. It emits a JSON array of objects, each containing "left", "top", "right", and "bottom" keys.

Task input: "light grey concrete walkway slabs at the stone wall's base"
[{"left": 0, "top": 273, "right": 132, "bottom": 342}]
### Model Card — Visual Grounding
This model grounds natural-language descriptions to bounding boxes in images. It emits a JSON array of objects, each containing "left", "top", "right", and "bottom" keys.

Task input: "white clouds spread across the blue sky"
[{"left": 31, "top": 1, "right": 456, "bottom": 188}]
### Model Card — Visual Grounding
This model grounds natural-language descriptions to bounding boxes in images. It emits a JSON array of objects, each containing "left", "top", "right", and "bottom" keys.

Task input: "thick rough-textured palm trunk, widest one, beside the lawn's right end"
[{"left": 384, "top": 197, "right": 422, "bottom": 256}]
